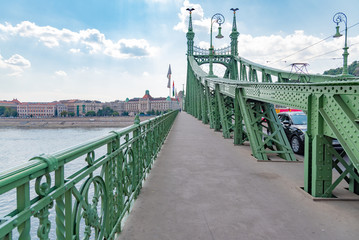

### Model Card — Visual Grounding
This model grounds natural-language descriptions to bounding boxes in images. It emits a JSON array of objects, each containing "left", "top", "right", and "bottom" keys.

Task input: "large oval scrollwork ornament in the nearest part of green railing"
[{"left": 74, "top": 176, "right": 108, "bottom": 239}]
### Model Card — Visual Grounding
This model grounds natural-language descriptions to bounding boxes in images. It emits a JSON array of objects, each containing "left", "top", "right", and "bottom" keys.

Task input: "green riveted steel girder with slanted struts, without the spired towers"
[{"left": 187, "top": 56, "right": 359, "bottom": 197}]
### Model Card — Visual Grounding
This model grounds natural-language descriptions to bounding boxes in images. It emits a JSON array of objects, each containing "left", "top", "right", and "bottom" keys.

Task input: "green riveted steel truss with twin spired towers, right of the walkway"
[{"left": 185, "top": 9, "right": 359, "bottom": 197}]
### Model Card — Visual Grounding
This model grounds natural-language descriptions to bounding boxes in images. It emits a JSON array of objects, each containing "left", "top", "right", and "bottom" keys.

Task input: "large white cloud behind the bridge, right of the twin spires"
[{"left": 238, "top": 30, "right": 359, "bottom": 73}]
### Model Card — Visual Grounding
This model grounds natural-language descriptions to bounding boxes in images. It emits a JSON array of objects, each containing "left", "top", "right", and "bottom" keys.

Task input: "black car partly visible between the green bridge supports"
[{"left": 278, "top": 112, "right": 307, "bottom": 154}]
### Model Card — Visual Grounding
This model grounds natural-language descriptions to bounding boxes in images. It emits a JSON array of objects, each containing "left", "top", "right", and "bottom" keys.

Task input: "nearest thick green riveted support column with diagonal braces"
[{"left": 304, "top": 94, "right": 359, "bottom": 198}]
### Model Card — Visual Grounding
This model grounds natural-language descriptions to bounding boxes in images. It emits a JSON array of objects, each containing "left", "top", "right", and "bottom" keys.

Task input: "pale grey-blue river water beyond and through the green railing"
[{"left": 0, "top": 128, "right": 120, "bottom": 239}]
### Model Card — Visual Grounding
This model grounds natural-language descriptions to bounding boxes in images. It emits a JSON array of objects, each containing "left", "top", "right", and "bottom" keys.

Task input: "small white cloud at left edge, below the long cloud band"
[{"left": 0, "top": 54, "right": 31, "bottom": 76}]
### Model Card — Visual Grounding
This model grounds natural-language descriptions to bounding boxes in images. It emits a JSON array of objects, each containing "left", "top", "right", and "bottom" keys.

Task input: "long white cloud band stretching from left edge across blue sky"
[{"left": 0, "top": 21, "right": 157, "bottom": 59}]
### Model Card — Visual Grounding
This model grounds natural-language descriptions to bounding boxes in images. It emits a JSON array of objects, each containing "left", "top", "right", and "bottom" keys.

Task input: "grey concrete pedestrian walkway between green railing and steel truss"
[{"left": 119, "top": 112, "right": 359, "bottom": 240}]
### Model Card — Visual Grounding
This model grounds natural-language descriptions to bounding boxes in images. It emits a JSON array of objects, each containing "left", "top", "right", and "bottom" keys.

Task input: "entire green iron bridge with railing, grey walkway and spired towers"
[{"left": 0, "top": 11, "right": 359, "bottom": 239}]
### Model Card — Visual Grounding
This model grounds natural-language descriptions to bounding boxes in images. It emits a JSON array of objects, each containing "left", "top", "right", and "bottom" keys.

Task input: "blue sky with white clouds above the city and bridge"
[{"left": 0, "top": 0, "right": 359, "bottom": 102}]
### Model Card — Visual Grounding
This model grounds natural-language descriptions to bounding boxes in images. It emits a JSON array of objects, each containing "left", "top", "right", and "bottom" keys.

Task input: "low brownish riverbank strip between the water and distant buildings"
[{"left": 0, "top": 116, "right": 154, "bottom": 128}]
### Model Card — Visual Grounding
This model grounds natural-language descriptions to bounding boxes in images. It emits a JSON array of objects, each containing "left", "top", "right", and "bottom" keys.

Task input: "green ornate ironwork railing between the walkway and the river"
[{"left": 0, "top": 111, "right": 178, "bottom": 239}]
